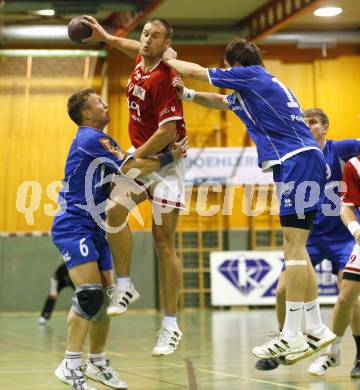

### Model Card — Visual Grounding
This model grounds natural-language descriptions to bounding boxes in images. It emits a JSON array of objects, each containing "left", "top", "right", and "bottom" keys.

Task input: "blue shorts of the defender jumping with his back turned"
[{"left": 273, "top": 149, "right": 326, "bottom": 219}]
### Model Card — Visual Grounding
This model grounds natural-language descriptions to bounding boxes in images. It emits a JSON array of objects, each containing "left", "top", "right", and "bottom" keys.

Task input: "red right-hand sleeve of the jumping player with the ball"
[{"left": 151, "top": 68, "right": 183, "bottom": 127}]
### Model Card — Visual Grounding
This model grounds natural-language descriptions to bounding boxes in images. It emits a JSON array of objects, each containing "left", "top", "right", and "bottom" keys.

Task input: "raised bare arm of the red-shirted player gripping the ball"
[{"left": 81, "top": 15, "right": 140, "bottom": 58}]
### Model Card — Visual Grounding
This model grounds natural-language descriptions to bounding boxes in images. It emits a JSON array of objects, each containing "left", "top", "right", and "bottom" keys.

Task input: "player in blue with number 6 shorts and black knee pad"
[{"left": 52, "top": 89, "right": 187, "bottom": 390}]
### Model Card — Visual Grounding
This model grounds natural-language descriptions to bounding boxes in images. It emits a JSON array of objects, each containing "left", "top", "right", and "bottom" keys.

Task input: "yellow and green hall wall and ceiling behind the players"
[{"left": 0, "top": 0, "right": 360, "bottom": 312}]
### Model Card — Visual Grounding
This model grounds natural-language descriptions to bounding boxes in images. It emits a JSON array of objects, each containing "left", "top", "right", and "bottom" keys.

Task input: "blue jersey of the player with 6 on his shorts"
[{"left": 55, "top": 127, "right": 131, "bottom": 221}]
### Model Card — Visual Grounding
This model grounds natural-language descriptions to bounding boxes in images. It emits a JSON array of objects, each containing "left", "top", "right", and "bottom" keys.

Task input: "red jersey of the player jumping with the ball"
[{"left": 126, "top": 55, "right": 186, "bottom": 148}]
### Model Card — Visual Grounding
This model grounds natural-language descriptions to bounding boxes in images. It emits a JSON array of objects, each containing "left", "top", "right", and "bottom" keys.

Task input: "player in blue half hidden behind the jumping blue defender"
[{"left": 256, "top": 108, "right": 360, "bottom": 375}]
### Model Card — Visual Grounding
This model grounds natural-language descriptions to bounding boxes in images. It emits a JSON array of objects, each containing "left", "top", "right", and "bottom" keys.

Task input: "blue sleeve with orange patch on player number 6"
[{"left": 78, "top": 134, "right": 133, "bottom": 173}]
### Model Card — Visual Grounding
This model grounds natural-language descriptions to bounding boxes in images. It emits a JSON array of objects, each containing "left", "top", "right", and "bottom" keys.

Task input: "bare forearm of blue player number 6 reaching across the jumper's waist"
[{"left": 121, "top": 137, "right": 189, "bottom": 176}]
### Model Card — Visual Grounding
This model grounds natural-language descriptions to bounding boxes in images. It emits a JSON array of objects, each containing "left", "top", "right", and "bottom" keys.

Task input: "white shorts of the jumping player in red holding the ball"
[{"left": 116, "top": 158, "right": 185, "bottom": 210}]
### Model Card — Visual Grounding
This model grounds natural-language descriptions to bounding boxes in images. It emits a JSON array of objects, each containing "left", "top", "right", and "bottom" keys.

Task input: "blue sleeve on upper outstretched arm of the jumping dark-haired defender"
[{"left": 207, "top": 66, "right": 257, "bottom": 90}]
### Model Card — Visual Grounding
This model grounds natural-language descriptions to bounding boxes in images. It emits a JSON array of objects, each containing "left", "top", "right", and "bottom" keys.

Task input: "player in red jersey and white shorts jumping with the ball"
[{"left": 83, "top": 16, "right": 185, "bottom": 356}]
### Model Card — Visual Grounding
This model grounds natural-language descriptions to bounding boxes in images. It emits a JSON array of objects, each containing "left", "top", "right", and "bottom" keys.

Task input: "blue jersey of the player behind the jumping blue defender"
[{"left": 308, "top": 139, "right": 360, "bottom": 245}]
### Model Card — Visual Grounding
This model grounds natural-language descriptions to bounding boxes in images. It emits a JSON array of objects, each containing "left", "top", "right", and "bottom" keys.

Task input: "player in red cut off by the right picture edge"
[{"left": 314, "top": 156, "right": 360, "bottom": 378}]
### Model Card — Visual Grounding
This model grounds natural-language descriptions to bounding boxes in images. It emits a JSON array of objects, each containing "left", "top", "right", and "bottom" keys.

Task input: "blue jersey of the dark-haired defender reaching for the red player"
[{"left": 208, "top": 65, "right": 319, "bottom": 168}]
